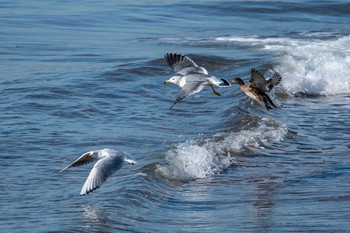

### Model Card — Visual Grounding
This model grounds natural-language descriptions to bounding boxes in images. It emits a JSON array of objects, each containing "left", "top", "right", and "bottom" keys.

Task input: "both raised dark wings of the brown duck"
[{"left": 250, "top": 68, "right": 282, "bottom": 92}]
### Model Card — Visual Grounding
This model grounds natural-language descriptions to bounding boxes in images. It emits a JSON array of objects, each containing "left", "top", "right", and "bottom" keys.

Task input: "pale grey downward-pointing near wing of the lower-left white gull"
[{"left": 80, "top": 155, "right": 124, "bottom": 195}]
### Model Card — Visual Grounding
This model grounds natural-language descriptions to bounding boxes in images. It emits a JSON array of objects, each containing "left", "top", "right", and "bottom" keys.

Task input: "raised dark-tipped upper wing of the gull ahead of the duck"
[{"left": 164, "top": 53, "right": 208, "bottom": 75}]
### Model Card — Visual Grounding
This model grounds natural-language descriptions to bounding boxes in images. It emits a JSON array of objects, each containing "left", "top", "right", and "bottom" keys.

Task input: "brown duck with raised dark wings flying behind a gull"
[{"left": 232, "top": 69, "right": 282, "bottom": 110}]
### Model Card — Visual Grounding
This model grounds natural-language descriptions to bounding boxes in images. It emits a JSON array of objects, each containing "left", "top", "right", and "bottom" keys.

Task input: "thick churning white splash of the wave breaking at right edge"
[{"left": 269, "top": 37, "right": 350, "bottom": 95}]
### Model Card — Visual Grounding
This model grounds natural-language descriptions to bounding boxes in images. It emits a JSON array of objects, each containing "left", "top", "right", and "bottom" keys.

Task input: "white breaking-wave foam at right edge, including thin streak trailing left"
[{"left": 216, "top": 36, "right": 350, "bottom": 95}]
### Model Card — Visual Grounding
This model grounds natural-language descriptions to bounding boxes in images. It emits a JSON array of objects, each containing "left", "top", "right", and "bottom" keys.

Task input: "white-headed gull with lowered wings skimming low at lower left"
[{"left": 60, "top": 148, "right": 136, "bottom": 196}]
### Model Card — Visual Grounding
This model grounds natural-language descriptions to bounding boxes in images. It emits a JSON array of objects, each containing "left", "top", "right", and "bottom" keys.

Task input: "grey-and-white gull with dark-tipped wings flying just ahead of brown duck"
[{"left": 164, "top": 53, "right": 231, "bottom": 109}]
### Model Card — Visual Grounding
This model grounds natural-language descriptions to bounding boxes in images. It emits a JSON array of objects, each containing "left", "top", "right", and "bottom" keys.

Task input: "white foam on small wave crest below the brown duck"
[{"left": 158, "top": 118, "right": 287, "bottom": 180}]
